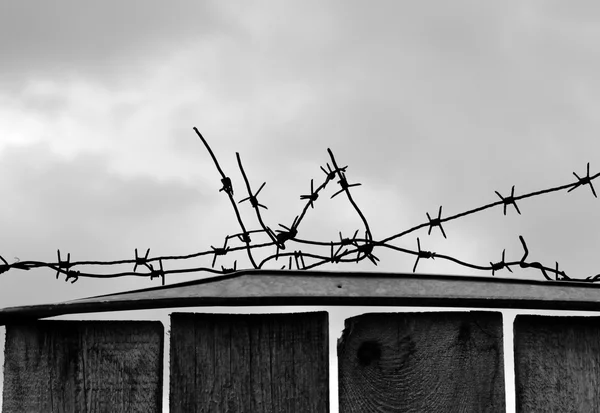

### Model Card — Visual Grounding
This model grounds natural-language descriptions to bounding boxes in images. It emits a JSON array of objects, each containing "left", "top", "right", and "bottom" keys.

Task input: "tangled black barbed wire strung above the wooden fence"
[{"left": 0, "top": 127, "right": 600, "bottom": 285}]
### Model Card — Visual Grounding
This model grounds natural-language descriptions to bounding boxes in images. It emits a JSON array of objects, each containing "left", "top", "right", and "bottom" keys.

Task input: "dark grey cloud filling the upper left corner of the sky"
[{"left": 0, "top": 0, "right": 223, "bottom": 83}]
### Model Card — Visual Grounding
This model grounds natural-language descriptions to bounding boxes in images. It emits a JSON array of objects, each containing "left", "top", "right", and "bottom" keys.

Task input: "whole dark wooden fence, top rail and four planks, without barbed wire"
[{"left": 0, "top": 271, "right": 600, "bottom": 412}]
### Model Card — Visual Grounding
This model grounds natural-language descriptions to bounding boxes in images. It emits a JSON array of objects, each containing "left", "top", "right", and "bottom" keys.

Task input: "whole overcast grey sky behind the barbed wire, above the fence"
[{"left": 0, "top": 0, "right": 600, "bottom": 408}]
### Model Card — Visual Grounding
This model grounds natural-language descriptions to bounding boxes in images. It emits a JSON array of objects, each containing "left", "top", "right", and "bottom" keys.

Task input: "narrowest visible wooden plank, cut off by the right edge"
[{"left": 514, "top": 315, "right": 600, "bottom": 412}]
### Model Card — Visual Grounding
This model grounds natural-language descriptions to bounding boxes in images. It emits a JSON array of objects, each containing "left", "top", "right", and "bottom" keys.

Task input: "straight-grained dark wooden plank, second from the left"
[{"left": 170, "top": 312, "right": 329, "bottom": 413}]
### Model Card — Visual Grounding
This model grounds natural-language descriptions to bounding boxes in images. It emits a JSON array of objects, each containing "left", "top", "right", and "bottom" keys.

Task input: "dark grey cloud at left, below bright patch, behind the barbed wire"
[{"left": 0, "top": 144, "right": 219, "bottom": 305}]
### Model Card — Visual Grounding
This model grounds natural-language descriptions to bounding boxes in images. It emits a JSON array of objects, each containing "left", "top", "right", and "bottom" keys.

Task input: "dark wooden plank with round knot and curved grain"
[{"left": 338, "top": 312, "right": 505, "bottom": 413}]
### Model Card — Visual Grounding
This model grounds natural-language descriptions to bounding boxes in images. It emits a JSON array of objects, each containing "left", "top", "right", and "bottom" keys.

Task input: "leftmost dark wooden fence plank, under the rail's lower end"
[{"left": 2, "top": 321, "right": 164, "bottom": 413}]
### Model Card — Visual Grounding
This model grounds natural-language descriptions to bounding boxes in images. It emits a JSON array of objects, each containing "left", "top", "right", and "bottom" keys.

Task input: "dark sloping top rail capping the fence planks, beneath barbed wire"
[{"left": 0, "top": 270, "right": 600, "bottom": 325}]
